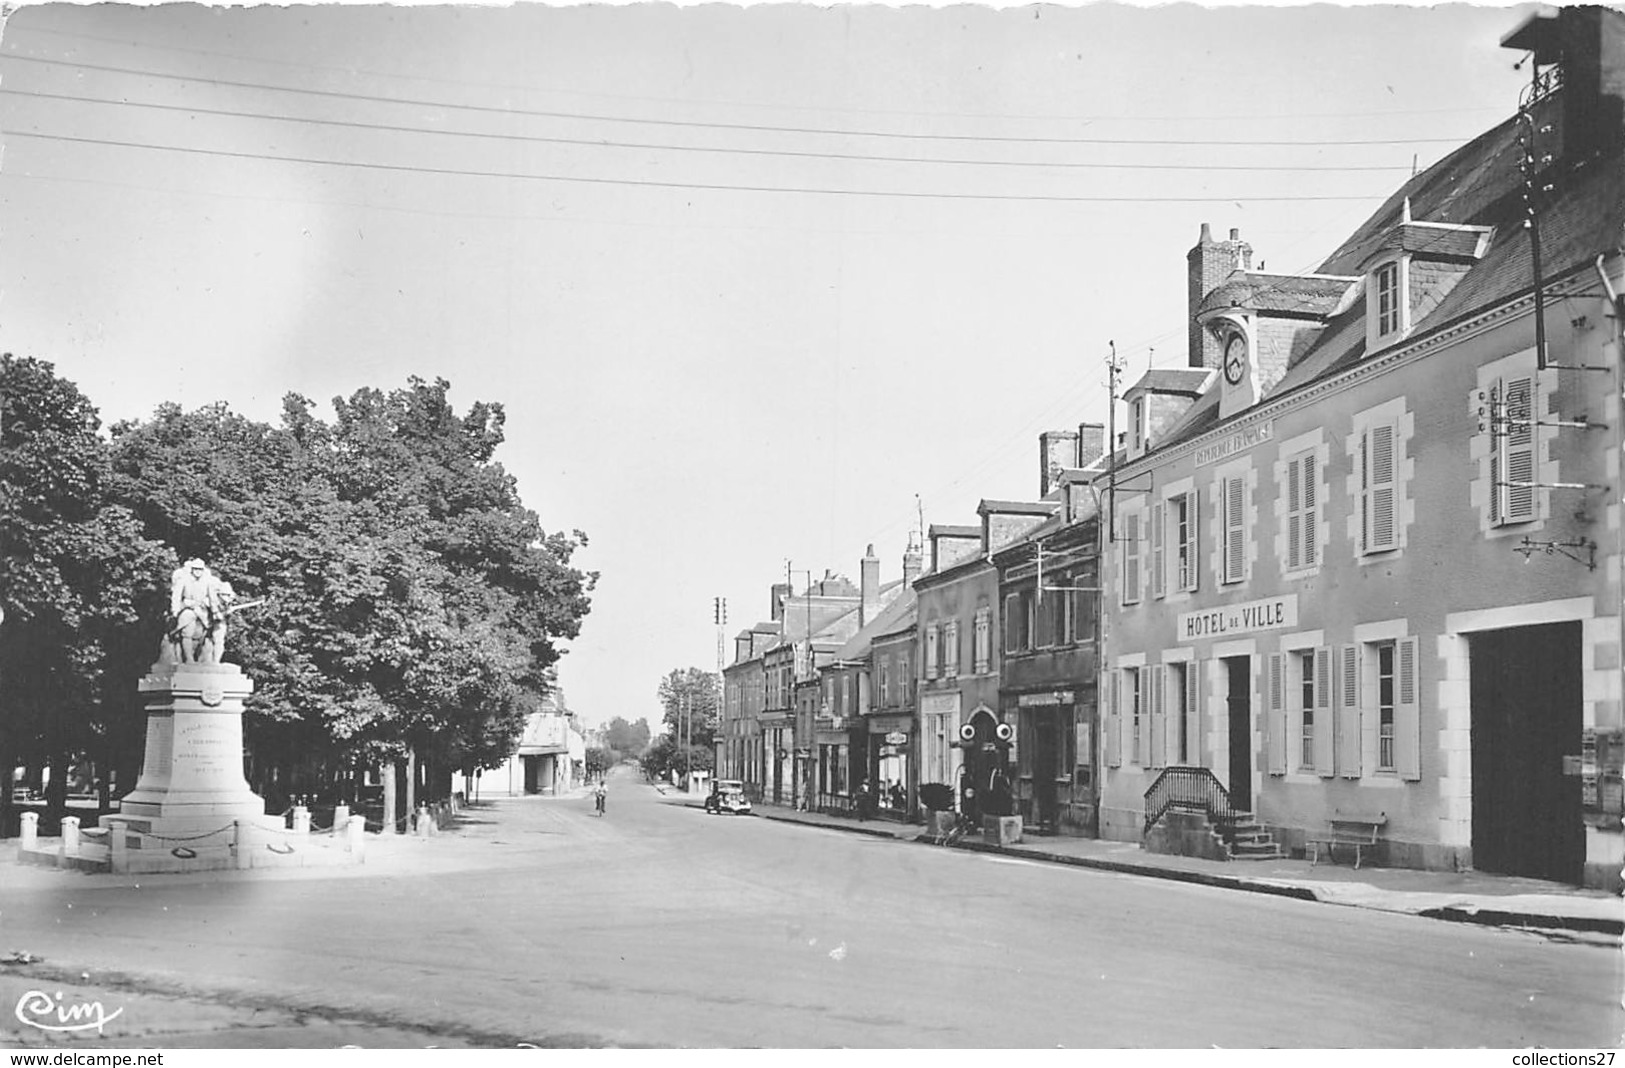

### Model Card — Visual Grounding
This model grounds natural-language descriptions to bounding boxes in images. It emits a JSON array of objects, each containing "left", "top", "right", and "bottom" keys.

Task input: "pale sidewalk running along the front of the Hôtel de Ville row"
[{"left": 666, "top": 790, "right": 1625, "bottom": 941}]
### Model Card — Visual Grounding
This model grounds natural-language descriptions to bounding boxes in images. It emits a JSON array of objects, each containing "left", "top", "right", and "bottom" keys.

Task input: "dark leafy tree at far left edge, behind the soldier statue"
[{"left": 0, "top": 353, "right": 174, "bottom": 821}]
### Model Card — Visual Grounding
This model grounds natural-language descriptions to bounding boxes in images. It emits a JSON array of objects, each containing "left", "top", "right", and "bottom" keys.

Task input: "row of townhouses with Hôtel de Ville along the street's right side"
[{"left": 717, "top": 8, "right": 1625, "bottom": 888}]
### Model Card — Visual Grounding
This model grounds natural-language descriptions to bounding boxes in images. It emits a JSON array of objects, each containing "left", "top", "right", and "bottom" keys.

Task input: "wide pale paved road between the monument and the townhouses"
[{"left": 0, "top": 775, "right": 1625, "bottom": 1047}]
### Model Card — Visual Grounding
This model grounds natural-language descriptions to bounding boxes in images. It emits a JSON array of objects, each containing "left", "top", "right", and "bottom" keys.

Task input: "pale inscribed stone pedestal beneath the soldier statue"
[{"left": 119, "top": 663, "right": 269, "bottom": 834}]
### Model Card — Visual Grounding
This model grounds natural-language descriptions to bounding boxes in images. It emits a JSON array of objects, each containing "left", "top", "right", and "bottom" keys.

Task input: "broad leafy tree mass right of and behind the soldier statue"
[{"left": 114, "top": 379, "right": 596, "bottom": 809}]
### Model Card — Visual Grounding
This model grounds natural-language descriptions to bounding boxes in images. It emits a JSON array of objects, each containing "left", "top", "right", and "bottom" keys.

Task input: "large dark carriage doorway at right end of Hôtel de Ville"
[{"left": 1469, "top": 623, "right": 1586, "bottom": 884}]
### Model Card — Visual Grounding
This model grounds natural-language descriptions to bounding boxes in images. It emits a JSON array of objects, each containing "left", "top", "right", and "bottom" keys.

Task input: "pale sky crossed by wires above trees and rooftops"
[{"left": 0, "top": 3, "right": 1528, "bottom": 723}]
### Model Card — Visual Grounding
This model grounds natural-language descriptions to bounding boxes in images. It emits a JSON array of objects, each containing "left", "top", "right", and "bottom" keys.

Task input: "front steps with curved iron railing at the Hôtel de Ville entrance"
[{"left": 1141, "top": 766, "right": 1285, "bottom": 860}]
